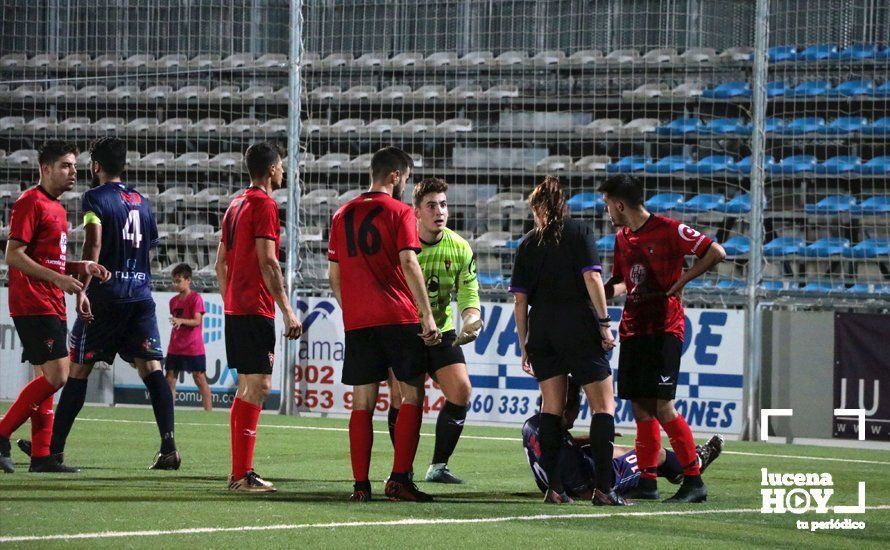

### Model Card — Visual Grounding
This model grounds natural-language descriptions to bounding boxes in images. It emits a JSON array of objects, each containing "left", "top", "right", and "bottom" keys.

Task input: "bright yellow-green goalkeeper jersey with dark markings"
[{"left": 417, "top": 227, "right": 481, "bottom": 332}]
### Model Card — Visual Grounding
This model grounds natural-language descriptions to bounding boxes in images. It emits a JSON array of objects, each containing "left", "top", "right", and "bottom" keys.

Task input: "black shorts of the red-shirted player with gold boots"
[{"left": 226, "top": 315, "right": 275, "bottom": 374}]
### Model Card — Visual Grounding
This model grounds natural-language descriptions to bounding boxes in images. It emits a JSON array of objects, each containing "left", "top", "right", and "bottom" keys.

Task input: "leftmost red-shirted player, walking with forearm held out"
[{"left": 0, "top": 141, "right": 110, "bottom": 473}]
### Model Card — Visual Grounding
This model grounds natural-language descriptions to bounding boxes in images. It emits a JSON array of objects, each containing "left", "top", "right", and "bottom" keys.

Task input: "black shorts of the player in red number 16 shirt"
[{"left": 342, "top": 323, "right": 426, "bottom": 386}]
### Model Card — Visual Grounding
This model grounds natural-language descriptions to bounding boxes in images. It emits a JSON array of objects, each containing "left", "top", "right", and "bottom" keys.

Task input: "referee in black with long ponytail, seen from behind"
[{"left": 510, "top": 176, "right": 627, "bottom": 506}]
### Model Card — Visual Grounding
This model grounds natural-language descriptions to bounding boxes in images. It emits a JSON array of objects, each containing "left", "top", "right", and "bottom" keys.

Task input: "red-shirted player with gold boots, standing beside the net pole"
[{"left": 216, "top": 143, "right": 303, "bottom": 493}]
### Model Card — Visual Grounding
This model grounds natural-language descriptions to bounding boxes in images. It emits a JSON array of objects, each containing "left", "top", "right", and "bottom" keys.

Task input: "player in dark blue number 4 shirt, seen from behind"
[{"left": 57, "top": 137, "right": 180, "bottom": 470}]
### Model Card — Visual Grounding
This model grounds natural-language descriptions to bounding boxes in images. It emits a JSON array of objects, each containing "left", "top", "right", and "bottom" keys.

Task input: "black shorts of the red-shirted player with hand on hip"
[{"left": 618, "top": 334, "right": 683, "bottom": 401}]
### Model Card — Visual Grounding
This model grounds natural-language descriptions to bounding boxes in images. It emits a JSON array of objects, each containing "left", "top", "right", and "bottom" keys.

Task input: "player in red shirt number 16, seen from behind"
[{"left": 328, "top": 147, "right": 442, "bottom": 502}]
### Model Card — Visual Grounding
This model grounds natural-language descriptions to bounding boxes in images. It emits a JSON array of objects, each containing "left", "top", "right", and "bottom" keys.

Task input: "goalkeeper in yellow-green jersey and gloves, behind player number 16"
[{"left": 389, "top": 178, "right": 482, "bottom": 483}]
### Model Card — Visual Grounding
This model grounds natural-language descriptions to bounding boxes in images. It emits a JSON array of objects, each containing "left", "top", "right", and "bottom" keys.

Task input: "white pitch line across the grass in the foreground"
[{"left": 0, "top": 504, "right": 890, "bottom": 542}]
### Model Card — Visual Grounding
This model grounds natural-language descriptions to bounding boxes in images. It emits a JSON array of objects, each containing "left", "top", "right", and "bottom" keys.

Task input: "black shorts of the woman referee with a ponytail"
[{"left": 526, "top": 304, "right": 612, "bottom": 386}]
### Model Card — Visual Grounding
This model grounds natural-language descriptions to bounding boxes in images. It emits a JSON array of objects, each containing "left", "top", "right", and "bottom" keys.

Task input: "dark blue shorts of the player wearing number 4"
[{"left": 69, "top": 299, "right": 164, "bottom": 365}]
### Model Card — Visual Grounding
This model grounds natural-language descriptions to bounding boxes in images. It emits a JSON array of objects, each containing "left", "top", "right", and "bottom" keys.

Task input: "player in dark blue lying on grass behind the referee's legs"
[{"left": 522, "top": 382, "right": 723, "bottom": 500}]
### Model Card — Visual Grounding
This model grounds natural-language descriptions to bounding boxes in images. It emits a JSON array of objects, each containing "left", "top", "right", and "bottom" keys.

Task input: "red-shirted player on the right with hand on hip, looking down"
[{"left": 598, "top": 174, "right": 726, "bottom": 503}]
